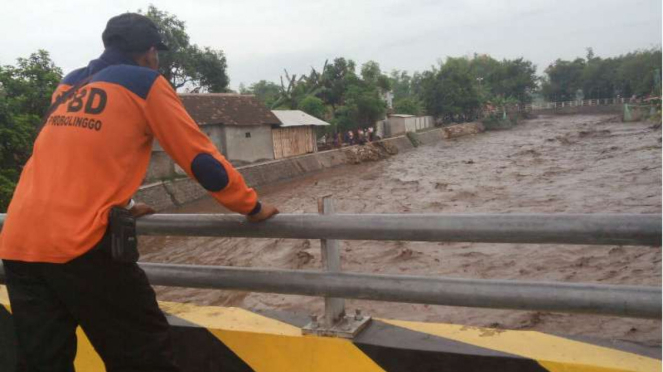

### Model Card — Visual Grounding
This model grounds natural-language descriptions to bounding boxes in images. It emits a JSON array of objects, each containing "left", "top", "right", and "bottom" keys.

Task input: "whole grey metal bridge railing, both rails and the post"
[{"left": 0, "top": 206, "right": 661, "bottom": 336}]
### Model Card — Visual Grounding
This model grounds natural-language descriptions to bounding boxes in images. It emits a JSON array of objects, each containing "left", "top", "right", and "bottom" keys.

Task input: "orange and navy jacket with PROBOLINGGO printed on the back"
[{"left": 0, "top": 49, "right": 261, "bottom": 263}]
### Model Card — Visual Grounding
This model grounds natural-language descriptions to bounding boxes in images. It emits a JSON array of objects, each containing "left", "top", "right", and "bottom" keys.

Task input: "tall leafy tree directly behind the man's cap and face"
[{"left": 138, "top": 5, "right": 229, "bottom": 92}]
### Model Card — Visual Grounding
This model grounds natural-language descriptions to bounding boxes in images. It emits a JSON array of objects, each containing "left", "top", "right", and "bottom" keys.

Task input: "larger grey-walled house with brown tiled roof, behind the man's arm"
[{"left": 147, "top": 93, "right": 281, "bottom": 181}]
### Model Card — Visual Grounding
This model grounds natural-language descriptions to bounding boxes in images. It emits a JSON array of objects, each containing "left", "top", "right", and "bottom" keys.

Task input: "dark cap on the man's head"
[{"left": 101, "top": 13, "right": 168, "bottom": 52}]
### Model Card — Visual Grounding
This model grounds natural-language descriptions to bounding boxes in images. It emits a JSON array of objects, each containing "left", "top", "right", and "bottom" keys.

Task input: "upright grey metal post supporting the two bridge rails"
[{"left": 318, "top": 195, "right": 345, "bottom": 328}]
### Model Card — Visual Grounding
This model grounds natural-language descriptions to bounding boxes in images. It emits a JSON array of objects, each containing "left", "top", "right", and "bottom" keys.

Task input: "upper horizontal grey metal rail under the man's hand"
[{"left": 137, "top": 214, "right": 661, "bottom": 245}]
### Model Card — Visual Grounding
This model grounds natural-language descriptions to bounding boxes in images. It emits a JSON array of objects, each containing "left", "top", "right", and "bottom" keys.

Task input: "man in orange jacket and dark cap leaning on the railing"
[{"left": 0, "top": 13, "right": 278, "bottom": 372}]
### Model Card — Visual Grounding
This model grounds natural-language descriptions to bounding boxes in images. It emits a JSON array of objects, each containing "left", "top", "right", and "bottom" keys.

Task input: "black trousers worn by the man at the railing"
[{"left": 3, "top": 238, "right": 179, "bottom": 372}]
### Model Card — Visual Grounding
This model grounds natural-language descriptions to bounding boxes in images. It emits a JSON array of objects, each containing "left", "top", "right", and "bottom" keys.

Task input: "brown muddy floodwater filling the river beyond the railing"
[{"left": 141, "top": 116, "right": 661, "bottom": 346}]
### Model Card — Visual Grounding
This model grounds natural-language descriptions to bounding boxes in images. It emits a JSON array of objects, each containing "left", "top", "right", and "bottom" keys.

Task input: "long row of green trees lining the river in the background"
[{"left": 247, "top": 49, "right": 661, "bottom": 129}]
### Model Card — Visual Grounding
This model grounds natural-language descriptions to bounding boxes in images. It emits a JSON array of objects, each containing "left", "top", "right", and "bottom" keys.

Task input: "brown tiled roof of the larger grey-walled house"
[{"left": 179, "top": 93, "right": 281, "bottom": 125}]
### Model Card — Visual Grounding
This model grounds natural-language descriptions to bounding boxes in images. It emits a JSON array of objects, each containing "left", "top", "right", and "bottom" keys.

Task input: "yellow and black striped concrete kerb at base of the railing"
[{"left": 0, "top": 286, "right": 662, "bottom": 372}]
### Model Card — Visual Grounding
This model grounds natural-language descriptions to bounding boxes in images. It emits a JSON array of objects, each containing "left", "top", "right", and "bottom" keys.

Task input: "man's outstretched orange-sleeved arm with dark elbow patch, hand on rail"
[{"left": 145, "top": 76, "right": 278, "bottom": 221}]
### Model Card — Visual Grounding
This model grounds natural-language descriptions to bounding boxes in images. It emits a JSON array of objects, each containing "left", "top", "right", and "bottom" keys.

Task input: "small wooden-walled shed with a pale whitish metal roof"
[{"left": 272, "top": 110, "right": 329, "bottom": 159}]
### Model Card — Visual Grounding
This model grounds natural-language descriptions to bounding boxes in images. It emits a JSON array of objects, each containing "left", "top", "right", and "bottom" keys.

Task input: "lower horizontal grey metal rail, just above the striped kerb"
[{"left": 141, "top": 263, "right": 661, "bottom": 319}]
